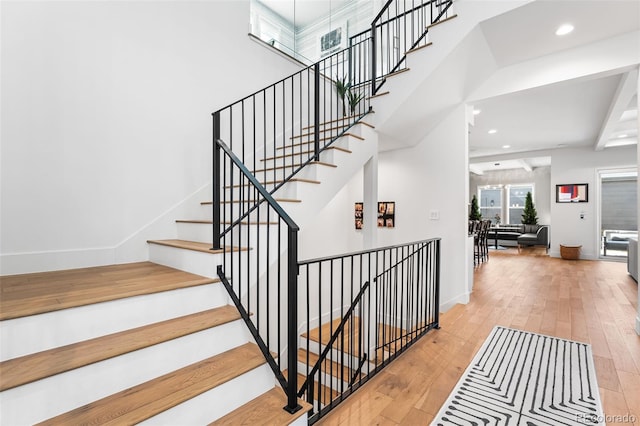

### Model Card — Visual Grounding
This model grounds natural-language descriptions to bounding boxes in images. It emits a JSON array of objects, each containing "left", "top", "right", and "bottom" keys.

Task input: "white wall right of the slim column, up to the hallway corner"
[{"left": 378, "top": 104, "right": 469, "bottom": 310}]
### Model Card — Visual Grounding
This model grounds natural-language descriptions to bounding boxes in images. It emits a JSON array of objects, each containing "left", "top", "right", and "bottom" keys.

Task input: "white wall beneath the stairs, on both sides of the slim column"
[{"left": 300, "top": 105, "right": 469, "bottom": 309}]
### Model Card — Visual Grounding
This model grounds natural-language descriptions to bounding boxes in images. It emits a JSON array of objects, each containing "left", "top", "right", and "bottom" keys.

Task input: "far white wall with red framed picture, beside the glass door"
[{"left": 549, "top": 146, "right": 637, "bottom": 259}]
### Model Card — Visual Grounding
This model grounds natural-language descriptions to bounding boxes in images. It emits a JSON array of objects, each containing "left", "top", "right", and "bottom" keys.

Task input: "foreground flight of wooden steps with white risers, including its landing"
[{"left": 0, "top": 262, "right": 308, "bottom": 424}]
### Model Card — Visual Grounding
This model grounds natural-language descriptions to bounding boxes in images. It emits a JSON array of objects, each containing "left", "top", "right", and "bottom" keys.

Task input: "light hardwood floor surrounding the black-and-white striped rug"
[{"left": 318, "top": 249, "right": 640, "bottom": 425}]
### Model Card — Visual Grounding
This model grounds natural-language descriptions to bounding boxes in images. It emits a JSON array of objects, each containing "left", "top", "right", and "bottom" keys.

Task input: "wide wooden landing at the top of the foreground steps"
[{"left": 0, "top": 262, "right": 219, "bottom": 320}]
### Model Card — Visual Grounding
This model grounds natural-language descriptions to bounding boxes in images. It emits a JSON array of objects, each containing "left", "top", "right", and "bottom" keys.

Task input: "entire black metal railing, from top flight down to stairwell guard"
[{"left": 211, "top": 0, "right": 452, "bottom": 422}]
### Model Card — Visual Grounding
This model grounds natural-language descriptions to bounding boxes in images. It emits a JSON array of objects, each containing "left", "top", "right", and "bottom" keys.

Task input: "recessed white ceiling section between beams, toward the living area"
[{"left": 470, "top": 75, "right": 620, "bottom": 157}]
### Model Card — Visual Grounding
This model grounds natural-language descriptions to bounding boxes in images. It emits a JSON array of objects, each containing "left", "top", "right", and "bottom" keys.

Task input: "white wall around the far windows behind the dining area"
[{"left": 469, "top": 167, "right": 551, "bottom": 225}]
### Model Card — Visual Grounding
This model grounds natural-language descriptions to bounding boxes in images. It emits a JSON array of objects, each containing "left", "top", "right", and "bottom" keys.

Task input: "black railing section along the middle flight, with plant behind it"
[{"left": 214, "top": 36, "right": 370, "bottom": 200}]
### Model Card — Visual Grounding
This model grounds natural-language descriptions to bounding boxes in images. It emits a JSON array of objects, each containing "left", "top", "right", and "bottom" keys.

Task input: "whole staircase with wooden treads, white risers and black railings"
[{"left": 0, "top": 2, "right": 460, "bottom": 425}]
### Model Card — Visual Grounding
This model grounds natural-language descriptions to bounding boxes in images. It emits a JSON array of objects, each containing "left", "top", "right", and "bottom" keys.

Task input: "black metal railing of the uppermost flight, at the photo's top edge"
[{"left": 351, "top": 0, "right": 453, "bottom": 95}]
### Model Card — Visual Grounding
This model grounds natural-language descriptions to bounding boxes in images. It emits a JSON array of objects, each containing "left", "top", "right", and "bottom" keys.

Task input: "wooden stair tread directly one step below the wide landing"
[{"left": 0, "top": 306, "right": 241, "bottom": 391}]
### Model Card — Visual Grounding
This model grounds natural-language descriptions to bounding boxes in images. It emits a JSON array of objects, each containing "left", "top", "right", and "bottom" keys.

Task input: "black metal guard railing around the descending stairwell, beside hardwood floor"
[{"left": 298, "top": 239, "right": 440, "bottom": 423}]
